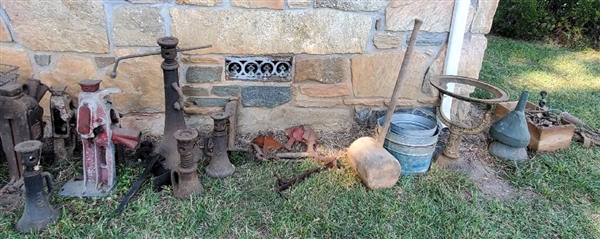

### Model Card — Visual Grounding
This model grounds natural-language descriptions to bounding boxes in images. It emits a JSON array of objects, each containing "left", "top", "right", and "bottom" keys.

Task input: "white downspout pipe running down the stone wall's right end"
[{"left": 441, "top": 0, "right": 471, "bottom": 122}]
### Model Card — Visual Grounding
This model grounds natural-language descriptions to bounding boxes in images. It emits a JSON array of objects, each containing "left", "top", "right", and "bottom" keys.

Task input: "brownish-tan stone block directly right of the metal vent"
[{"left": 294, "top": 56, "right": 350, "bottom": 84}]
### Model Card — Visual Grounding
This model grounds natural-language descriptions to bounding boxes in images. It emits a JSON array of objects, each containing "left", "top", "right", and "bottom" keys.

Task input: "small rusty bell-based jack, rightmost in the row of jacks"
[{"left": 204, "top": 101, "right": 237, "bottom": 178}]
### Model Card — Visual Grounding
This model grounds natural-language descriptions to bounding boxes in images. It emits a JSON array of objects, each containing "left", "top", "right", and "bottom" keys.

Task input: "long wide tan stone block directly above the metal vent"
[{"left": 171, "top": 7, "right": 373, "bottom": 54}]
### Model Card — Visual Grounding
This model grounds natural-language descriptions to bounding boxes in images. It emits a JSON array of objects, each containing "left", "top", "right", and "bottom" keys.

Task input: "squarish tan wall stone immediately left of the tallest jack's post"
[{"left": 102, "top": 49, "right": 165, "bottom": 113}]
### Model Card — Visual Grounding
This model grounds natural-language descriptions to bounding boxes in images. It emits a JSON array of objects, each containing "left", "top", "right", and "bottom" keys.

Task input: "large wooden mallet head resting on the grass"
[{"left": 347, "top": 137, "right": 402, "bottom": 189}]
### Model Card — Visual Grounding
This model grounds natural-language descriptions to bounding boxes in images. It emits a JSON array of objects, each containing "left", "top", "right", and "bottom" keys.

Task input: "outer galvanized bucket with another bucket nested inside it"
[{"left": 377, "top": 116, "right": 441, "bottom": 175}]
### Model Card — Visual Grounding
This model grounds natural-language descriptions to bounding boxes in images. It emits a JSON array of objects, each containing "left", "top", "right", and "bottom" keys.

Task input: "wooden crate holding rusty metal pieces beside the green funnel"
[{"left": 494, "top": 101, "right": 575, "bottom": 152}]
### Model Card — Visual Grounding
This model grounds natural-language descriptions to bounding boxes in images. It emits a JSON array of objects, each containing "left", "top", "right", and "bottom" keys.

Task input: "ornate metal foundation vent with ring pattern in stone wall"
[{"left": 225, "top": 56, "right": 294, "bottom": 81}]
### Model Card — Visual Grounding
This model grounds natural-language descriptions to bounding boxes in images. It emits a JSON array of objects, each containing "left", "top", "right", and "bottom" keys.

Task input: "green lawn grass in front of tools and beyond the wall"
[{"left": 0, "top": 37, "right": 600, "bottom": 238}]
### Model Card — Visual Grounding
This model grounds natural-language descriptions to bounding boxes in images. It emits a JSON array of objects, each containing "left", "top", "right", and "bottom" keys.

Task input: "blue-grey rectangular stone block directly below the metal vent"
[{"left": 242, "top": 86, "right": 292, "bottom": 108}]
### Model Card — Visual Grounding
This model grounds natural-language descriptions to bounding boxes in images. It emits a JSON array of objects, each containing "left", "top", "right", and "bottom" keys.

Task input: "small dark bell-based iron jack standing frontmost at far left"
[{"left": 15, "top": 140, "right": 60, "bottom": 233}]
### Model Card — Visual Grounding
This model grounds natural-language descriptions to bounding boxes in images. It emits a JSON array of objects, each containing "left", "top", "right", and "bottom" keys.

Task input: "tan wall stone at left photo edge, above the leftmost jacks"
[{"left": 0, "top": 43, "right": 33, "bottom": 82}]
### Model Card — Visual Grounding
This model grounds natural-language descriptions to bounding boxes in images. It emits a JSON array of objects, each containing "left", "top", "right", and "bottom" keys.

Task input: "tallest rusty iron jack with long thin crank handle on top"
[{"left": 110, "top": 37, "right": 212, "bottom": 169}]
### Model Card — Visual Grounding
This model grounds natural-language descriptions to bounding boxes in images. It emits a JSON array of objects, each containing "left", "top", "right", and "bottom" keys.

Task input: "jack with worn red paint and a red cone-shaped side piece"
[{"left": 60, "top": 80, "right": 141, "bottom": 197}]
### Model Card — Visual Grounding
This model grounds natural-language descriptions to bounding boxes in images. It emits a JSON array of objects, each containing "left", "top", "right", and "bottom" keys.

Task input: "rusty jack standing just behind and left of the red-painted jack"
[{"left": 50, "top": 86, "right": 77, "bottom": 162}]
